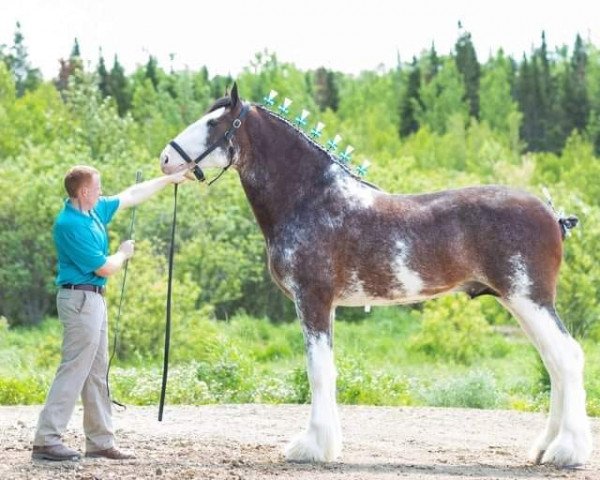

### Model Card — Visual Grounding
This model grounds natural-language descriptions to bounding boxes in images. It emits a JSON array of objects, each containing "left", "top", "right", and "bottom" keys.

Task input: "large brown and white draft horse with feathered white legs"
[{"left": 159, "top": 84, "right": 592, "bottom": 467}]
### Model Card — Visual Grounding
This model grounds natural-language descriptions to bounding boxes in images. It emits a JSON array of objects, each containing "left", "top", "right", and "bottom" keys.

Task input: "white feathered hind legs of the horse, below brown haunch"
[{"left": 500, "top": 292, "right": 592, "bottom": 467}]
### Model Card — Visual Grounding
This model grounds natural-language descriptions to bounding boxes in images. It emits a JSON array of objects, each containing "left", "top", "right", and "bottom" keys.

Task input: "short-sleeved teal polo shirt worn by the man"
[{"left": 52, "top": 197, "right": 119, "bottom": 286}]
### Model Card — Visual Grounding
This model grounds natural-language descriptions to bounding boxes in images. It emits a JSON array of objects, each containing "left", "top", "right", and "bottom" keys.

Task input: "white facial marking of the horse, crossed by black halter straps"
[{"left": 160, "top": 108, "right": 229, "bottom": 174}]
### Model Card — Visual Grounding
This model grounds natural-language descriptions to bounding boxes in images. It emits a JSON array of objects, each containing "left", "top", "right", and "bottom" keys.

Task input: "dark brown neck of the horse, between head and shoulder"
[{"left": 239, "top": 113, "right": 338, "bottom": 237}]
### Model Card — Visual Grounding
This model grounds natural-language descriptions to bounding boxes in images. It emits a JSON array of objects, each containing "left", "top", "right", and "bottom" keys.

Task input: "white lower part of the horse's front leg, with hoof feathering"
[{"left": 285, "top": 333, "right": 342, "bottom": 462}]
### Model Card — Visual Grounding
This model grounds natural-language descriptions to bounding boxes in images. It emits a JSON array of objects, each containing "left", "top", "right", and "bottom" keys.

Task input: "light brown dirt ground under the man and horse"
[{"left": 0, "top": 405, "right": 600, "bottom": 480}]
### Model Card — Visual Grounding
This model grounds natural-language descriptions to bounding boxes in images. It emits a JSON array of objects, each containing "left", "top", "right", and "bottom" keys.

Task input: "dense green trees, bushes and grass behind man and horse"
[{"left": 0, "top": 26, "right": 600, "bottom": 414}]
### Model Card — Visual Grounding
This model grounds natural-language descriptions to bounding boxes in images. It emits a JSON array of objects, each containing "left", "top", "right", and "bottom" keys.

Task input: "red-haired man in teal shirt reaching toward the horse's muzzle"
[{"left": 32, "top": 166, "right": 189, "bottom": 461}]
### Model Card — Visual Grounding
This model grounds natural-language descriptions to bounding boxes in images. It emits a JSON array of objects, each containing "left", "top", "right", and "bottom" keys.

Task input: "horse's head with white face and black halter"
[{"left": 160, "top": 83, "right": 250, "bottom": 180}]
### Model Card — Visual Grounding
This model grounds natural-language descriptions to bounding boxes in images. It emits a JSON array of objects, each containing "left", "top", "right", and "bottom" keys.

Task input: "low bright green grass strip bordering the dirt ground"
[{"left": 0, "top": 308, "right": 600, "bottom": 415}]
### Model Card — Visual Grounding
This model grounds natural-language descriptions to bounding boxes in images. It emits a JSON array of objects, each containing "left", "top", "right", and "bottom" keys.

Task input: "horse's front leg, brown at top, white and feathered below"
[{"left": 285, "top": 292, "right": 342, "bottom": 462}]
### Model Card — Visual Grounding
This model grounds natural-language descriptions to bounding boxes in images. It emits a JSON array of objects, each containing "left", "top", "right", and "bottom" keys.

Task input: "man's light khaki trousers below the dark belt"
[{"left": 33, "top": 289, "right": 114, "bottom": 452}]
